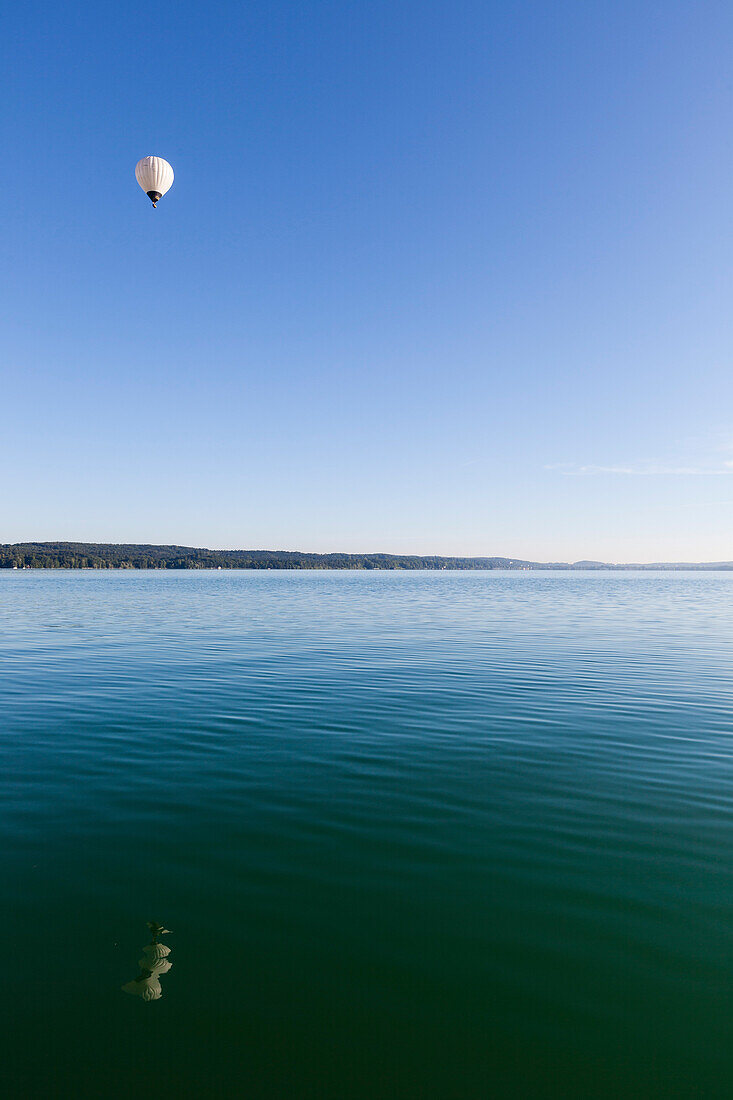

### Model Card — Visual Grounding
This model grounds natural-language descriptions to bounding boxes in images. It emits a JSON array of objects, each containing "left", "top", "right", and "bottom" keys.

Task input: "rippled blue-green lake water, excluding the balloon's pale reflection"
[{"left": 0, "top": 571, "right": 733, "bottom": 1100}]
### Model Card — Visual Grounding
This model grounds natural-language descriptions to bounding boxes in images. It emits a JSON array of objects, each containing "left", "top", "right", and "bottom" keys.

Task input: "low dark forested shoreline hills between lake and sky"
[{"left": 0, "top": 542, "right": 733, "bottom": 570}]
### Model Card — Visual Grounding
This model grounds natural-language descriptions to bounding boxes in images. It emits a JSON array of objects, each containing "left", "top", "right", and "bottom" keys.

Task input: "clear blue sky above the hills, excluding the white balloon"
[{"left": 0, "top": 0, "right": 733, "bottom": 560}]
